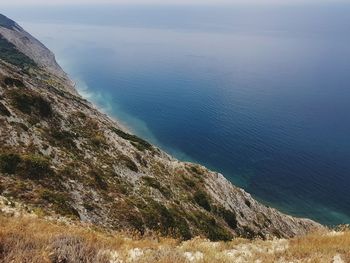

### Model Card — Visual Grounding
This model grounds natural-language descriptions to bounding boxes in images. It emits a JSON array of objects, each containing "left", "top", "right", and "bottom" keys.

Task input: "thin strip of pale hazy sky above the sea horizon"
[{"left": 0, "top": 0, "right": 348, "bottom": 6}]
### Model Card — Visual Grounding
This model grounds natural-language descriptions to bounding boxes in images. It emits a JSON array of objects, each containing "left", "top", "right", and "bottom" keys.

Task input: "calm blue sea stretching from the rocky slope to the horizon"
[{"left": 5, "top": 4, "right": 350, "bottom": 225}]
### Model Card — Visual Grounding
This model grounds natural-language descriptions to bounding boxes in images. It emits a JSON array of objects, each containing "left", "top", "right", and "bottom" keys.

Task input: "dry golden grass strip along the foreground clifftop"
[{"left": 0, "top": 215, "right": 350, "bottom": 263}]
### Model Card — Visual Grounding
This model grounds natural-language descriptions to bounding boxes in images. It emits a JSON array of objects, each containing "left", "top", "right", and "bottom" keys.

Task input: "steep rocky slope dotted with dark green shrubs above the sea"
[{"left": 0, "top": 13, "right": 321, "bottom": 240}]
